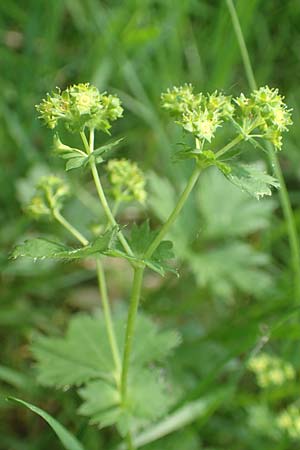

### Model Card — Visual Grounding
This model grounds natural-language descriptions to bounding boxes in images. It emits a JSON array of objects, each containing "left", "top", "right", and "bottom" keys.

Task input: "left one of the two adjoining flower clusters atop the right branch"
[{"left": 161, "top": 84, "right": 234, "bottom": 142}]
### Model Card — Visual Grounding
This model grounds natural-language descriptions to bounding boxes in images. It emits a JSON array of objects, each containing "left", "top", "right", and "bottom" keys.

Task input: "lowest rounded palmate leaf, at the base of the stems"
[{"left": 79, "top": 368, "right": 178, "bottom": 436}]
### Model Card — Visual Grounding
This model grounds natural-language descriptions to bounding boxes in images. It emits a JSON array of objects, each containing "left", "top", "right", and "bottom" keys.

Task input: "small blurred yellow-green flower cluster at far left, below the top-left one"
[{"left": 26, "top": 175, "right": 69, "bottom": 218}]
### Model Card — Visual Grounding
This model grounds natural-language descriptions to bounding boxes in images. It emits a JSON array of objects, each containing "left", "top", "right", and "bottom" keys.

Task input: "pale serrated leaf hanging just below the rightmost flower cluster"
[{"left": 226, "top": 164, "right": 280, "bottom": 200}]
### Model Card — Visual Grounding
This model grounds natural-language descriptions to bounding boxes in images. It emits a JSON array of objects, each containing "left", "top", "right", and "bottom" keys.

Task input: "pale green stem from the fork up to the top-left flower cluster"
[{"left": 80, "top": 130, "right": 133, "bottom": 256}]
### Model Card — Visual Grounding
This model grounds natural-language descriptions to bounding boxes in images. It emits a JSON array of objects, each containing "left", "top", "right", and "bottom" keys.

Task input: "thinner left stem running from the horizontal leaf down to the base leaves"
[{"left": 96, "top": 258, "right": 121, "bottom": 374}]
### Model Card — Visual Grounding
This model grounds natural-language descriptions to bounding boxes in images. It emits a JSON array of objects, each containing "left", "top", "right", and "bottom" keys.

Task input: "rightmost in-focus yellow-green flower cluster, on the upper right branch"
[{"left": 234, "top": 86, "right": 293, "bottom": 150}]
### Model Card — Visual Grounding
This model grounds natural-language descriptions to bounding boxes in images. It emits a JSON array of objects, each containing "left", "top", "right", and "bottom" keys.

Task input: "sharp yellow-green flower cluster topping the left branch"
[{"left": 36, "top": 83, "right": 123, "bottom": 132}]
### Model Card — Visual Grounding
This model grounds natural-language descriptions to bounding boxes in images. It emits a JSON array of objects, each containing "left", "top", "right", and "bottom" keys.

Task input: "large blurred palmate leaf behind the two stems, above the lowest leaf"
[{"left": 31, "top": 315, "right": 180, "bottom": 387}]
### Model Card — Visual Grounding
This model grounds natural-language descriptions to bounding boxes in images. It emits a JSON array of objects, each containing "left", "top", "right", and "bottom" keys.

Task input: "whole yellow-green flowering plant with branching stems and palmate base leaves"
[{"left": 13, "top": 83, "right": 294, "bottom": 450}]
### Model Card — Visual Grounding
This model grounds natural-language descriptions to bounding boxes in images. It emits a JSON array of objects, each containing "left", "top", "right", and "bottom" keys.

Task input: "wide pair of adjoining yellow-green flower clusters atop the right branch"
[{"left": 161, "top": 84, "right": 292, "bottom": 149}]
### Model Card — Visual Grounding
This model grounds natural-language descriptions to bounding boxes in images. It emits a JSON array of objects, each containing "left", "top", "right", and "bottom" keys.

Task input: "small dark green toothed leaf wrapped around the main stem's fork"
[{"left": 109, "top": 220, "right": 177, "bottom": 276}]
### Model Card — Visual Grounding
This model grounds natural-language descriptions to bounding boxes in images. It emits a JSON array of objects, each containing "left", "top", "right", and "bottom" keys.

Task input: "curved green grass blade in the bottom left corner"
[{"left": 8, "top": 397, "right": 84, "bottom": 450}]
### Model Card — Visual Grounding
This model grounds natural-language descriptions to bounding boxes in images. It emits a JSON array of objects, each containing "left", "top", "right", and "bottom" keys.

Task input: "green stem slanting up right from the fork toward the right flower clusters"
[{"left": 144, "top": 166, "right": 202, "bottom": 259}]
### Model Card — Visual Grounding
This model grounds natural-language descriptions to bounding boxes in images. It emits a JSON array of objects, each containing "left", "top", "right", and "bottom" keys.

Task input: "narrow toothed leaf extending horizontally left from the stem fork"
[{"left": 12, "top": 228, "right": 115, "bottom": 260}]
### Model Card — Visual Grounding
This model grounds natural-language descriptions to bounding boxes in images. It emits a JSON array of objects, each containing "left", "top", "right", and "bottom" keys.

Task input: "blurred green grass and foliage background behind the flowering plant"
[{"left": 0, "top": 0, "right": 300, "bottom": 450}]
